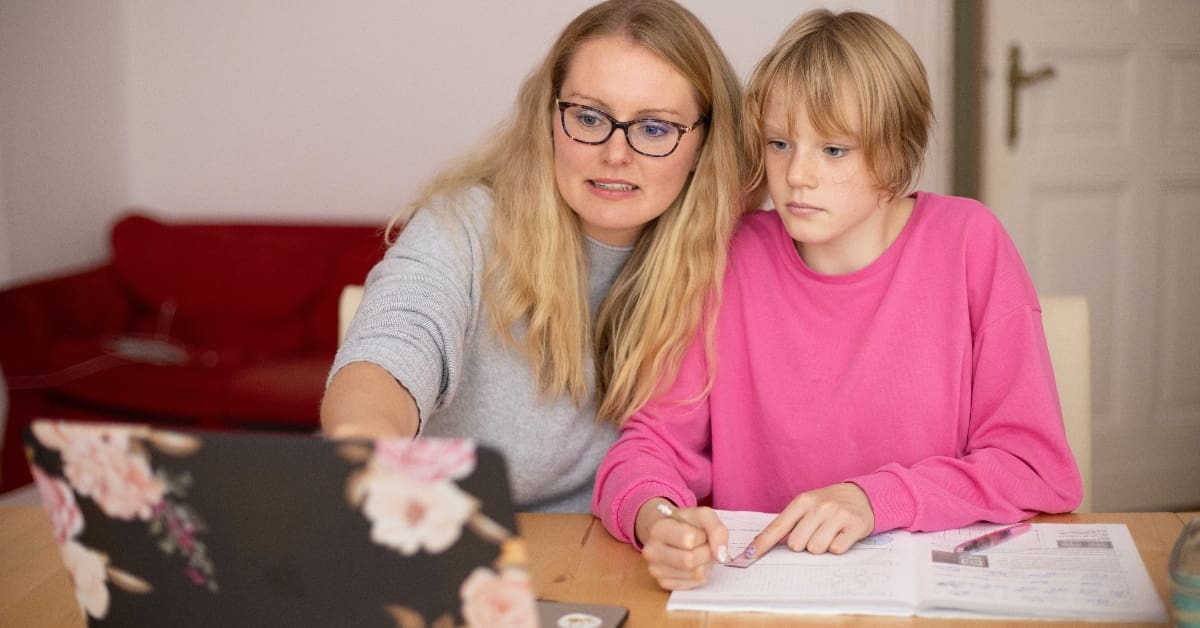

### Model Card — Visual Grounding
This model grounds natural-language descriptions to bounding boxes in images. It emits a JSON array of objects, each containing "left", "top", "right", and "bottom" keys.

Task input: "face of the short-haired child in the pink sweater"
[{"left": 763, "top": 94, "right": 912, "bottom": 275}]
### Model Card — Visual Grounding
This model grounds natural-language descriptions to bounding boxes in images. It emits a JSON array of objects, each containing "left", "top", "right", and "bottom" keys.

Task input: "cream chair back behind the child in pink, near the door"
[{"left": 1039, "top": 294, "right": 1092, "bottom": 513}]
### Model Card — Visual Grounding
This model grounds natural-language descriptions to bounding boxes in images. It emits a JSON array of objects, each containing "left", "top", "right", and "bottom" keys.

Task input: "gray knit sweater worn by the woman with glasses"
[{"left": 330, "top": 190, "right": 632, "bottom": 512}]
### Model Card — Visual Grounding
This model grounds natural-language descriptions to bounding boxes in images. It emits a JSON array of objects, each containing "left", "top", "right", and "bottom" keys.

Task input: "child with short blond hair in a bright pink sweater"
[{"left": 593, "top": 11, "right": 1082, "bottom": 588}]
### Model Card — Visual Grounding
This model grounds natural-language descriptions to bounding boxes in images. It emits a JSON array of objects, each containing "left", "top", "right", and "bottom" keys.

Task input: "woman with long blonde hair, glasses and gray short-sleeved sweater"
[{"left": 322, "top": 0, "right": 746, "bottom": 512}]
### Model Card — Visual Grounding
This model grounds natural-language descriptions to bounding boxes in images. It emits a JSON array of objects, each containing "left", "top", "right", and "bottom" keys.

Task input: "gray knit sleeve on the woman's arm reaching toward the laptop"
[{"left": 330, "top": 190, "right": 490, "bottom": 430}]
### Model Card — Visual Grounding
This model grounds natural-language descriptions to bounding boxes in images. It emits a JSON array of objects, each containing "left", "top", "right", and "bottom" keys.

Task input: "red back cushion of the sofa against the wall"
[{"left": 113, "top": 215, "right": 332, "bottom": 364}]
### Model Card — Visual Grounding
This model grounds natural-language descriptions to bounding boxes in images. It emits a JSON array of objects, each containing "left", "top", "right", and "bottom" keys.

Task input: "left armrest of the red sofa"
[{"left": 0, "top": 264, "right": 131, "bottom": 376}]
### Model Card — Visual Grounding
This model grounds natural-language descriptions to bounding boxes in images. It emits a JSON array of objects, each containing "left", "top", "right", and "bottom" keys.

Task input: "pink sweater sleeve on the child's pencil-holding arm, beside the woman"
[{"left": 592, "top": 330, "right": 713, "bottom": 548}]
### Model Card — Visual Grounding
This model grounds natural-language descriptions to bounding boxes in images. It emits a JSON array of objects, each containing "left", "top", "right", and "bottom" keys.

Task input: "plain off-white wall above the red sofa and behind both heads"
[{"left": 0, "top": 0, "right": 950, "bottom": 283}]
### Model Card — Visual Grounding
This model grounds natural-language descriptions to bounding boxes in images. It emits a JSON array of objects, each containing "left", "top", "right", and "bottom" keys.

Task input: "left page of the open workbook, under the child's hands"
[{"left": 667, "top": 510, "right": 916, "bottom": 615}]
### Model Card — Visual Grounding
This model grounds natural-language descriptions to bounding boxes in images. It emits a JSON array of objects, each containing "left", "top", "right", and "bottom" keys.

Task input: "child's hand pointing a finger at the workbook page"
[{"left": 750, "top": 483, "right": 875, "bottom": 556}]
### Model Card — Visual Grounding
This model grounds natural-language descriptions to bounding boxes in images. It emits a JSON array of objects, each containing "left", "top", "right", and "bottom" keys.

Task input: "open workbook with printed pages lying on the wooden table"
[{"left": 667, "top": 510, "right": 1168, "bottom": 622}]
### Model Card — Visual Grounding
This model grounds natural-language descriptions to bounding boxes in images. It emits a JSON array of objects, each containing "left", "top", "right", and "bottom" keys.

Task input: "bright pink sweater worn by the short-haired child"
[{"left": 592, "top": 193, "right": 1082, "bottom": 542}]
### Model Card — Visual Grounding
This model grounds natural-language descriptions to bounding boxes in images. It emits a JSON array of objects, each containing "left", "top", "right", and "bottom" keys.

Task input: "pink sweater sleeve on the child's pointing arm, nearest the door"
[{"left": 851, "top": 214, "right": 1082, "bottom": 532}]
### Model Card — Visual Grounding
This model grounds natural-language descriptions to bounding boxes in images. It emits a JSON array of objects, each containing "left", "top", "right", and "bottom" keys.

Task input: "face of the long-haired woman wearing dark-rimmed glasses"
[{"left": 553, "top": 35, "right": 704, "bottom": 246}]
